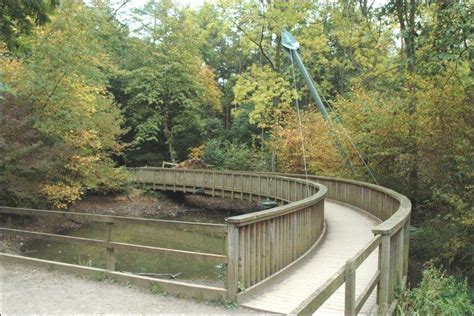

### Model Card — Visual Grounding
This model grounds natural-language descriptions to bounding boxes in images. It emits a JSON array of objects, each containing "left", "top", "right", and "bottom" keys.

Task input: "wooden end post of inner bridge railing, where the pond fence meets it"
[{"left": 227, "top": 224, "right": 239, "bottom": 301}]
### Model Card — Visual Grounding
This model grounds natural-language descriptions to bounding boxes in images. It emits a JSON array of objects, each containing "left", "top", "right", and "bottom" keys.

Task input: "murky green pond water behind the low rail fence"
[{"left": 23, "top": 211, "right": 232, "bottom": 286}]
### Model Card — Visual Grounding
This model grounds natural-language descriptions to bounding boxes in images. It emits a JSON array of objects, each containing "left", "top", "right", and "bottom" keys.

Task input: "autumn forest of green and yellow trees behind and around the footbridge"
[{"left": 0, "top": 0, "right": 474, "bottom": 315}]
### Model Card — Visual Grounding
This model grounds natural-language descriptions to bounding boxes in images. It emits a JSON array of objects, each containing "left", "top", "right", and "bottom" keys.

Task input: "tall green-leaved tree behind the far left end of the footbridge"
[{"left": 120, "top": 1, "right": 220, "bottom": 162}]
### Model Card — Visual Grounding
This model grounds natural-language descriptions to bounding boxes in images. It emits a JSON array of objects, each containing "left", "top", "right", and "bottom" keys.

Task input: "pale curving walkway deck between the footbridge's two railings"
[{"left": 240, "top": 201, "right": 378, "bottom": 315}]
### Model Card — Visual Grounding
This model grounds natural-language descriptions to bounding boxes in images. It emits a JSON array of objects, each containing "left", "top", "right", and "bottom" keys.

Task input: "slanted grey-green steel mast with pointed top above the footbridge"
[{"left": 281, "top": 30, "right": 354, "bottom": 173}]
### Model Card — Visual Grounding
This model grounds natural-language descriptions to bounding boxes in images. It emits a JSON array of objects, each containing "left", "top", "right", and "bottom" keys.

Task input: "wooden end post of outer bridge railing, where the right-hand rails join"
[{"left": 378, "top": 235, "right": 390, "bottom": 315}]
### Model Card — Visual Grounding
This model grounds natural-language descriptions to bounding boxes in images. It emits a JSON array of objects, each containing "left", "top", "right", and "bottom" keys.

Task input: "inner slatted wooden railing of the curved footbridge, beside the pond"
[{"left": 128, "top": 168, "right": 326, "bottom": 300}]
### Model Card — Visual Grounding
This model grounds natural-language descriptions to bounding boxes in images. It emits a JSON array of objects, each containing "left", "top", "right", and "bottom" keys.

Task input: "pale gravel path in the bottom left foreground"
[{"left": 0, "top": 263, "right": 253, "bottom": 315}]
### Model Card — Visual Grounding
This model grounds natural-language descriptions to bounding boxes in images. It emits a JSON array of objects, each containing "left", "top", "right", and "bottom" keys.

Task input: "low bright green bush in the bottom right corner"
[{"left": 396, "top": 267, "right": 474, "bottom": 316}]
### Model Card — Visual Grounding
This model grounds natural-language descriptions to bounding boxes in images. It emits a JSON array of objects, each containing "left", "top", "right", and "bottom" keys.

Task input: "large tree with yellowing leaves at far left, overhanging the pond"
[{"left": 1, "top": 3, "right": 125, "bottom": 208}]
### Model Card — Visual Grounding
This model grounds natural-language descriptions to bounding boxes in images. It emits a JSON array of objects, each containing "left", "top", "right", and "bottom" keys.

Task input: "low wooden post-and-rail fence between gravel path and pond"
[{"left": 0, "top": 206, "right": 227, "bottom": 299}]
